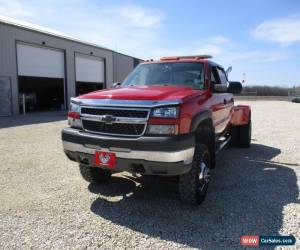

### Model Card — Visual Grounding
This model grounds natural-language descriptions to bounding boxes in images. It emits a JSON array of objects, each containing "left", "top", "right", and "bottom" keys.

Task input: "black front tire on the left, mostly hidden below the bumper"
[{"left": 79, "top": 164, "right": 111, "bottom": 183}]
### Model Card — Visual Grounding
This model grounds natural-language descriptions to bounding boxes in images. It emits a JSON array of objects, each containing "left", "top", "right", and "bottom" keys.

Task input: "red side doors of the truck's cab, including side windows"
[{"left": 211, "top": 66, "right": 233, "bottom": 134}]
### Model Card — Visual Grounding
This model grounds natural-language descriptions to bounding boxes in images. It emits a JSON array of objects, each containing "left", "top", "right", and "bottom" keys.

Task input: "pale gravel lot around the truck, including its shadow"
[{"left": 0, "top": 101, "right": 300, "bottom": 249}]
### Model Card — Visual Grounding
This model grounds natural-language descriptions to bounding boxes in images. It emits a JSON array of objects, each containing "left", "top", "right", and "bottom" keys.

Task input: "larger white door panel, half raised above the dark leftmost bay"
[{"left": 17, "top": 44, "right": 65, "bottom": 78}]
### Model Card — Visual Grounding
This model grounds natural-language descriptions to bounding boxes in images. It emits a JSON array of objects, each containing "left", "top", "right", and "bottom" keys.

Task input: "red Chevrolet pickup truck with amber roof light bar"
[{"left": 62, "top": 56, "right": 251, "bottom": 204}]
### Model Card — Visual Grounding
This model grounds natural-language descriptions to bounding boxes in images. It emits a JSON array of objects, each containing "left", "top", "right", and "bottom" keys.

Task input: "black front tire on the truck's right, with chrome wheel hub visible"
[{"left": 179, "top": 143, "right": 211, "bottom": 205}]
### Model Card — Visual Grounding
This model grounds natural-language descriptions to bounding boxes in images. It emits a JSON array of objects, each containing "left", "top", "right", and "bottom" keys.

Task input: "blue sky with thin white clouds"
[{"left": 0, "top": 0, "right": 300, "bottom": 87}]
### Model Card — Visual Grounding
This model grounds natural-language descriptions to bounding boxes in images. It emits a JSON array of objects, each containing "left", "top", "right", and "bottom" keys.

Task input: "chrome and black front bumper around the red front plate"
[{"left": 62, "top": 128, "right": 195, "bottom": 175}]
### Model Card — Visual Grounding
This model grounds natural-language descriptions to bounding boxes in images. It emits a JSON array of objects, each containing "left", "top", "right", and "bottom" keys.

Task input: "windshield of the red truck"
[{"left": 122, "top": 62, "right": 204, "bottom": 89}]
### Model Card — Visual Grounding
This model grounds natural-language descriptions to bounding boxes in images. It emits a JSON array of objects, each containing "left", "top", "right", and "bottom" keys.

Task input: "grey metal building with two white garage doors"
[{"left": 0, "top": 19, "right": 141, "bottom": 116}]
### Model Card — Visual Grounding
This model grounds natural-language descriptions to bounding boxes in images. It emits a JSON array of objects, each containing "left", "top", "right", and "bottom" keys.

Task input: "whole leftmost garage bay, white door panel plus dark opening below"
[{"left": 17, "top": 43, "right": 66, "bottom": 112}]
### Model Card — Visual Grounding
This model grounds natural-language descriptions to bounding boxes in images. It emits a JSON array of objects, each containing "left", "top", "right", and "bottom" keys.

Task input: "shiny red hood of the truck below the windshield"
[{"left": 78, "top": 85, "right": 205, "bottom": 101}]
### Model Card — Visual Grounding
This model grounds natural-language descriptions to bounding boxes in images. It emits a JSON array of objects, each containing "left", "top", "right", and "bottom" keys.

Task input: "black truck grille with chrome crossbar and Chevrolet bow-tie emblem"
[{"left": 81, "top": 107, "right": 150, "bottom": 136}]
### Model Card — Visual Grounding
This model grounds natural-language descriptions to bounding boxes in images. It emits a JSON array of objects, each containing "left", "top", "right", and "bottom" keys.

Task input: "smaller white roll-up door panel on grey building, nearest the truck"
[{"left": 75, "top": 54, "right": 104, "bottom": 83}]
